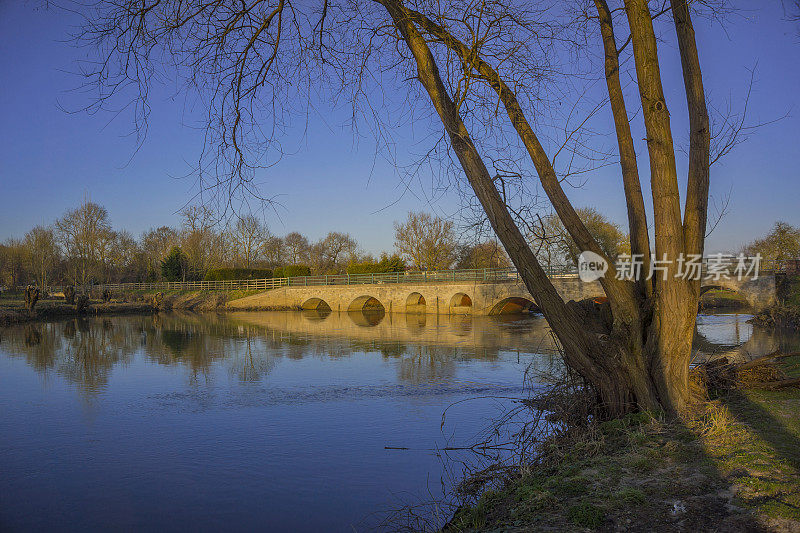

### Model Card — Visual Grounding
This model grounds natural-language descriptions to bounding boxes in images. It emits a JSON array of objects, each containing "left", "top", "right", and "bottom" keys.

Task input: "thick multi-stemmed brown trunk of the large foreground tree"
[{"left": 382, "top": 0, "right": 708, "bottom": 417}]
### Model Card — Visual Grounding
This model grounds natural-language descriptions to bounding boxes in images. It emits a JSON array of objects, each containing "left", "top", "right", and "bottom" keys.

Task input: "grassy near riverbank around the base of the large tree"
[{"left": 443, "top": 355, "right": 800, "bottom": 532}]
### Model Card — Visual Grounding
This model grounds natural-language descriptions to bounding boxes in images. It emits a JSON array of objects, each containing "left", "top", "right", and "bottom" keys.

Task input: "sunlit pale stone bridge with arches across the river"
[{"left": 228, "top": 275, "right": 776, "bottom": 315}]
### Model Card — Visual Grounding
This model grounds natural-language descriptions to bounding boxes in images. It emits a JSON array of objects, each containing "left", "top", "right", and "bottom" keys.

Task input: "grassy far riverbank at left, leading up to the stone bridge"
[{"left": 0, "top": 290, "right": 257, "bottom": 326}]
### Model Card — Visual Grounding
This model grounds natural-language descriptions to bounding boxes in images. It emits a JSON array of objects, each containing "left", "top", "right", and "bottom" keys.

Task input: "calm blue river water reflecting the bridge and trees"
[{"left": 0, "top": 312, "right": 800, "bottom": 531}]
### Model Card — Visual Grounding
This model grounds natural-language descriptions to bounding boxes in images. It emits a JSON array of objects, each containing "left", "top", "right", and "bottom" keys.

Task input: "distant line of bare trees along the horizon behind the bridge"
[{"left": 0, "top": 200, "right": 511, "bottom": 289}]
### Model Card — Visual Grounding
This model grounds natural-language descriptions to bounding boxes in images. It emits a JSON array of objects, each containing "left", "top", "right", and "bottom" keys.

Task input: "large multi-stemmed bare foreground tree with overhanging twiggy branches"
[{"left": 75, "top": 0, "right": 710, "bottom": 416}]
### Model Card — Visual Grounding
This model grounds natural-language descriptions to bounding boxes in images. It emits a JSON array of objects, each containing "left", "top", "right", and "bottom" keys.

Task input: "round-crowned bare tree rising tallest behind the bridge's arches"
[{"left": 394, "top": 212, "right": 457, "bottom": 270}]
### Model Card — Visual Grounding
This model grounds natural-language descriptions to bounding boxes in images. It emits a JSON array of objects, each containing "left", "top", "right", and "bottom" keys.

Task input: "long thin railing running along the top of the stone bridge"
[{"left": 50, "top": 257, "right": 784, "bottom": 292}]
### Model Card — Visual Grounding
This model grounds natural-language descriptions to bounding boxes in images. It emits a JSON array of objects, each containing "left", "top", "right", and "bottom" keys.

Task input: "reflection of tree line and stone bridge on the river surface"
[{"left": 2, "top": 312, "right": 580, "bottom": 392}]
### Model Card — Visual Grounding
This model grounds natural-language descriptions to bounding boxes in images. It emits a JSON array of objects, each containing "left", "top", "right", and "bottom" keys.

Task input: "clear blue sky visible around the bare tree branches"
[{"left": 0, "top": 0, "right": 800, "bottom": 252}]
